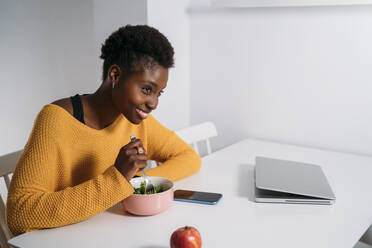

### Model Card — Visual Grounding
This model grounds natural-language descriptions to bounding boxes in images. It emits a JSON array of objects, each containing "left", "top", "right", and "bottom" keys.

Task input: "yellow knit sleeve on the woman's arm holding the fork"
[{"left": 6, "top": 108, "right": 134, "bottom": 235}]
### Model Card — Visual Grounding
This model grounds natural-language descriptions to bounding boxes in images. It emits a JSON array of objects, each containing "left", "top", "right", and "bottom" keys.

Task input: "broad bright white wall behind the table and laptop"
[{"left": 190, "top": 6, "right": 372, "bottom": 155}]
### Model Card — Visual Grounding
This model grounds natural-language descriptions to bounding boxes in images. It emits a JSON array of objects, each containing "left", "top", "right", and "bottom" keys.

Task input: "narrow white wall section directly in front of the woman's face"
[{"left": 147, "top": 0, "right": 190, "bottom": 130}]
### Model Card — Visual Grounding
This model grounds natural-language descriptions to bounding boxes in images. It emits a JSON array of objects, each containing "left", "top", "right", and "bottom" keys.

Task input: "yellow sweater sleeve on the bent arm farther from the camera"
[{"left": 142, "top": 115, "right": 201, "bottom": 181}]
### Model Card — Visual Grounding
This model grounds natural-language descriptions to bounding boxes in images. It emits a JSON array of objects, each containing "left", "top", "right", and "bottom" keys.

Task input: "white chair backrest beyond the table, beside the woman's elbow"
[{"left": 176, "top": 121, "right": 217, "bottom": 154}]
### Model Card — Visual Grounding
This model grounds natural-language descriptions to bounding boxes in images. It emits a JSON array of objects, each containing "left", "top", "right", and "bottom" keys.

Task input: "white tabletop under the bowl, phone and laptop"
[{"left": 9, "top": 140, "right": 372, "bottom": 248}]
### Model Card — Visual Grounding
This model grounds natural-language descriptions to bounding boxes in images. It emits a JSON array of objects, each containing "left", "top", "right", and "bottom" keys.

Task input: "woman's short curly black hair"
[{"left": 100, "top": 25, "right": 174, "bottom": 81}]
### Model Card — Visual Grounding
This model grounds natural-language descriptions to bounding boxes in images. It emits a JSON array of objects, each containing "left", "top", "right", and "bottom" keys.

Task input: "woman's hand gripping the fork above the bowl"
[{"left": 114, "top": 139, "right": 148, "bottom": 181}]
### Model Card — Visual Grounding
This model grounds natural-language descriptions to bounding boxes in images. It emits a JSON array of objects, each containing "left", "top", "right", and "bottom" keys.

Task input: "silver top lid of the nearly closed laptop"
[{"left": 255, "top": 157, "right": 335, "bottom": 199}]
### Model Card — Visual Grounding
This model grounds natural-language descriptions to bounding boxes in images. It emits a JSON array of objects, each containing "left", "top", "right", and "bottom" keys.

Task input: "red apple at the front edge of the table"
[{"left": 170, "top": 226, "right": 201, "bottom": 248}]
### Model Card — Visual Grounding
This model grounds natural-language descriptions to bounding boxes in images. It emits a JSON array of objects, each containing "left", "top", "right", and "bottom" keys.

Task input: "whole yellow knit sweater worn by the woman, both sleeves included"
[{"left": 7, "top": 104, "right": 201, "bottom": 235}]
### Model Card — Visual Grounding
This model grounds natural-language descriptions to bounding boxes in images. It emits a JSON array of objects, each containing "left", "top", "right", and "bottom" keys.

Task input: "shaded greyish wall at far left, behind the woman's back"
[{"left": 0, "top": 0, "right": 97, "bottom": 154}]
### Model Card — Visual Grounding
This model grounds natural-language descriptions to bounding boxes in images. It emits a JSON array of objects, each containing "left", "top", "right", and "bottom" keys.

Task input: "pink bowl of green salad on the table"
[{"left": 122, "top": 177, "right": 174, "bottom": 215}]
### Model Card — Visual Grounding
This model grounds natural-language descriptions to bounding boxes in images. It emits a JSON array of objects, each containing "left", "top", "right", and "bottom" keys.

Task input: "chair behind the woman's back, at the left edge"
[{"left": 0, "top": 150, "right": 23, "bottom": 247}]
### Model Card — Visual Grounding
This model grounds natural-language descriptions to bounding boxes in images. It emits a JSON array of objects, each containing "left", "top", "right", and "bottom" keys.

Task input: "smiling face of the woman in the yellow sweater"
[{"left": 112, "top": 65, "right": 168, "bottom": 124}]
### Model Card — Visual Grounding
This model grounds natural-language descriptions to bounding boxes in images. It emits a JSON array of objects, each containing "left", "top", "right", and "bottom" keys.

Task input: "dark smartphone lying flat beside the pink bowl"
[{"left": 174, "top": 189, "right": 222, "bottom": 205}]
